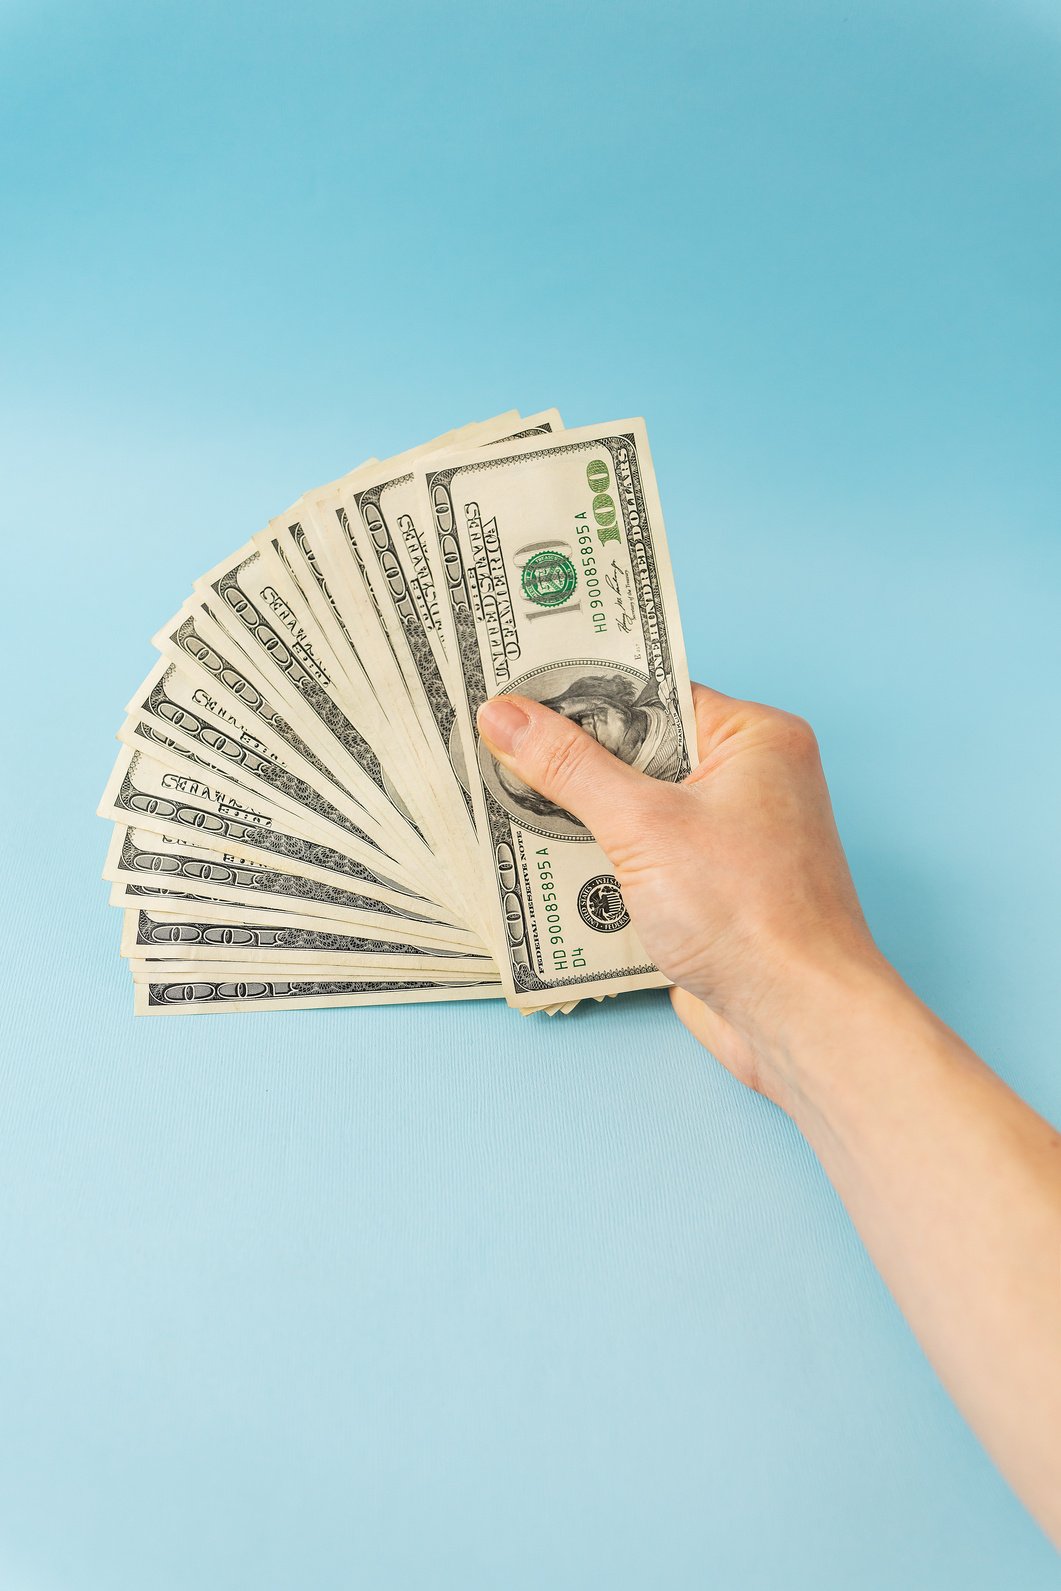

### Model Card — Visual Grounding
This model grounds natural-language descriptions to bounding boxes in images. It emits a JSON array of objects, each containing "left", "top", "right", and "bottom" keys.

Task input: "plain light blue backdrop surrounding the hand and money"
[{"left": 0, "top": 0, "right": 1061, "bottom": 1591}]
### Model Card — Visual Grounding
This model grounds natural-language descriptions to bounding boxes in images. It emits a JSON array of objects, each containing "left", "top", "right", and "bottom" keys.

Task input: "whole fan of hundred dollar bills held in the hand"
[{"left": 99, "top": 410, "right": 695, "bottom": 1013}]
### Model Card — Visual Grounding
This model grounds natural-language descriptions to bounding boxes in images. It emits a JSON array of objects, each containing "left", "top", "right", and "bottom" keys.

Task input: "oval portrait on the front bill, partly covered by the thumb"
[{"left": 480, "top": 668, "right": 682, "bottom": 837}]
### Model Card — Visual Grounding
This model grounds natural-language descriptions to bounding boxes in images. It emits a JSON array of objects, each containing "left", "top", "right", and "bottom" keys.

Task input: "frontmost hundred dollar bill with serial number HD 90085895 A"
[{"left": 418, "top": 420, "right": 695, "bottom": 1007}]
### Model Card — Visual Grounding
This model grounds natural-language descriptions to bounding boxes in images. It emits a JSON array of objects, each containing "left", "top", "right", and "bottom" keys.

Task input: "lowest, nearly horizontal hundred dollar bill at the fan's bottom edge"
[{"left": 134, "top": 978, "right": 501, "bottom": 1017}]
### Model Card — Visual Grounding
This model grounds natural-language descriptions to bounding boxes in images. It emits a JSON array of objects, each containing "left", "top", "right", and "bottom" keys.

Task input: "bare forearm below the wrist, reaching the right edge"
[{"left": 776, "top": 964, "right": 1061, "bottom": 1545}]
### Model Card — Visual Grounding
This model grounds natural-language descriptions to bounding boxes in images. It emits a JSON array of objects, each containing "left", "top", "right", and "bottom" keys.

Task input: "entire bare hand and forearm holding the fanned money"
[{"left": 479, "top": 686, "right": 1061, "bottom": 1548}]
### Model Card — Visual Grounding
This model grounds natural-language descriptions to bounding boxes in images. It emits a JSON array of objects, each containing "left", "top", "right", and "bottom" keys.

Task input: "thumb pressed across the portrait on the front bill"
[{"left": 477, "top": 695, "right": 662, "bottom": 851}]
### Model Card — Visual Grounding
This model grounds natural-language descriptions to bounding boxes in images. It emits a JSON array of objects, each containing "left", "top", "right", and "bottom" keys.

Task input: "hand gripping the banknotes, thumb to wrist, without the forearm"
[{"left": 479, "top": 686, "right": 884, "bottom": 1107}]
